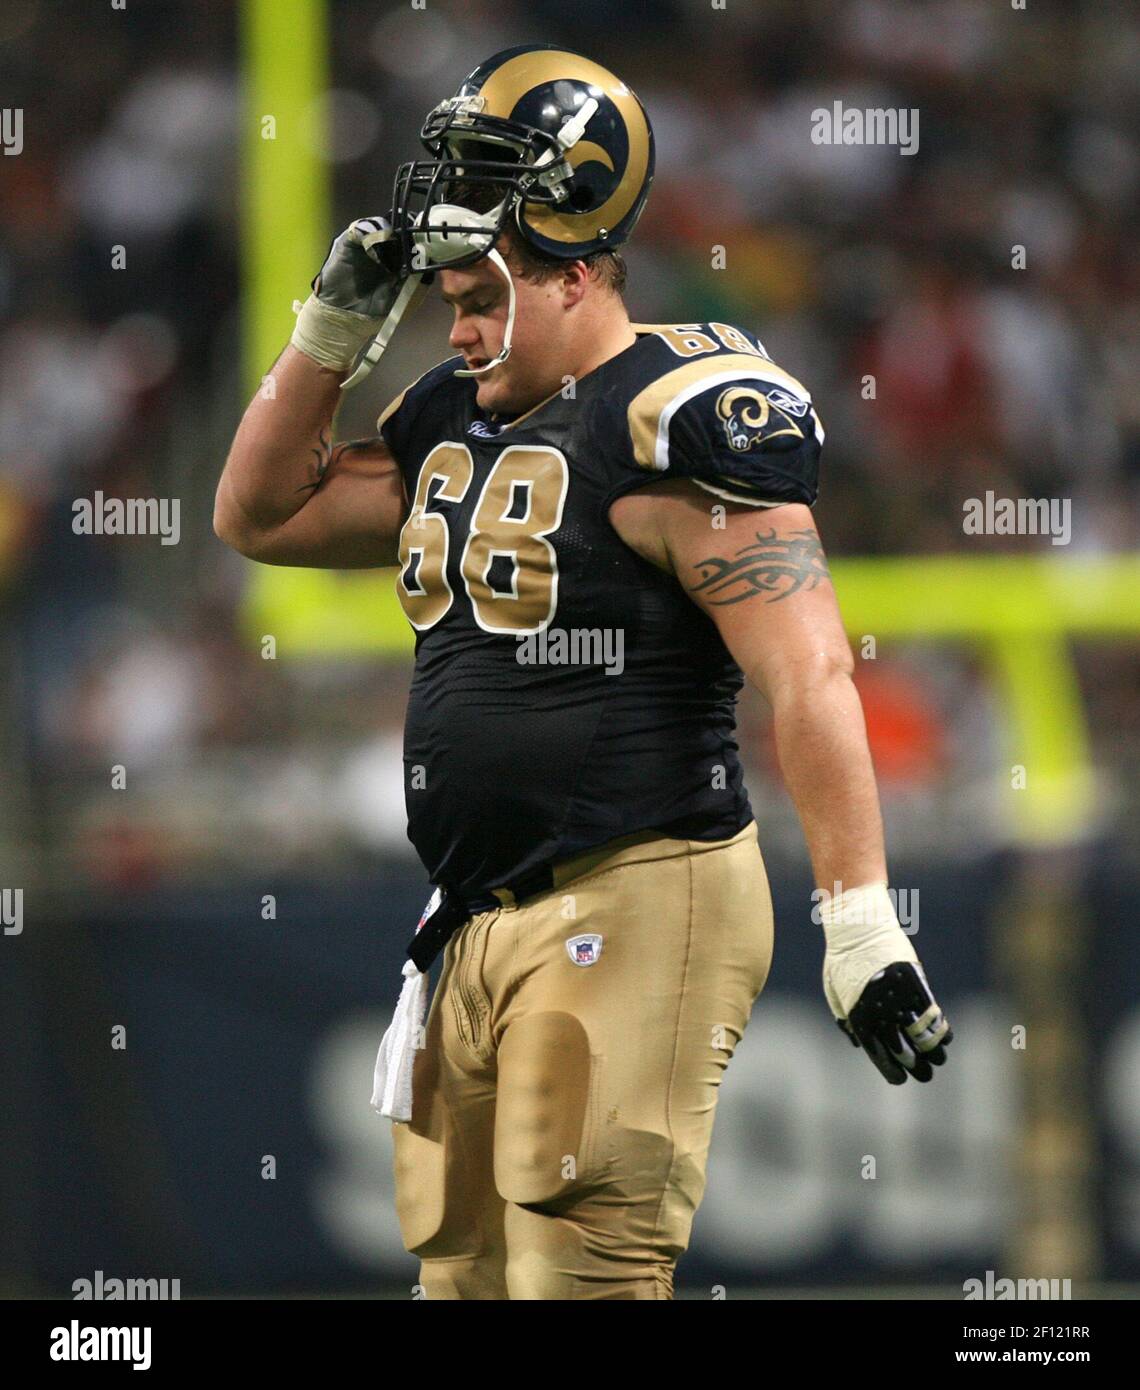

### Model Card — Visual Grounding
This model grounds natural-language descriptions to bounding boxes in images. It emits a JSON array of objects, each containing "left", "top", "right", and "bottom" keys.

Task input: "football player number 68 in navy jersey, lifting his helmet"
[{"left": 215, "top": 46, "right": 951, "bottom": 1298}]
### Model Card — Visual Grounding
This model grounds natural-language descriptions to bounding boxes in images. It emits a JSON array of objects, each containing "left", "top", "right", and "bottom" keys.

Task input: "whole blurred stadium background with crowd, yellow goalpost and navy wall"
[{"left": 0, "top": 0, "right": 1140, "bottom": 1297}]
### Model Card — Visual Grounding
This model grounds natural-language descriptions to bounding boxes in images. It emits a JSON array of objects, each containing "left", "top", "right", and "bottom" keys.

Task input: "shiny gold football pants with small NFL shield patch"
[{"left": 393, "top": 821, "right": 772, "bottom": 1298}]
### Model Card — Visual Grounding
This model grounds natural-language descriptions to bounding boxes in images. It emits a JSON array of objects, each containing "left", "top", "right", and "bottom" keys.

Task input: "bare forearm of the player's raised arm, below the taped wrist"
[{"left": 214, "top": 346, "right": 345, "bottom": 550}]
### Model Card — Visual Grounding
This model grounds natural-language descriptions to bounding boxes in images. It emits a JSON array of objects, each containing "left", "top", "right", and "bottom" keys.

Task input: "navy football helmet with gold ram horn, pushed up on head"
[{"left": 392, "top": 43, "right": 653, "bottom": 272}]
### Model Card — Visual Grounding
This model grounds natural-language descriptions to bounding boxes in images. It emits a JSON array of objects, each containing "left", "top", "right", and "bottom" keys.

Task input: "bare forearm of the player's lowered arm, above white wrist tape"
[{"left": 772, "top": 663, "right": 887, "bottom": 892}]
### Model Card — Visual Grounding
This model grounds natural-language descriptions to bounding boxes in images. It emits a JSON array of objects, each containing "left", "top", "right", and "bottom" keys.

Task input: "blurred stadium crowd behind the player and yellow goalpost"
[{"left": 0, "top": 0, "right": 1140, "bottom": 885}]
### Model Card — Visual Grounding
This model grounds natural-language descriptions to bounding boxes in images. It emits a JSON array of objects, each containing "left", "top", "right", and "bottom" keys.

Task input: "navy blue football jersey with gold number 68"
[{"left": 378, "top": 324, "right": 823, "bottom": 902}]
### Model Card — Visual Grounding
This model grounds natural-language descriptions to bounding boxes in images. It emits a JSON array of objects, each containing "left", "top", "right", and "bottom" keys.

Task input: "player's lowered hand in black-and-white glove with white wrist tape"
[{"left": 820, "top": 884, "right": 954, "bottom": 1086}]
